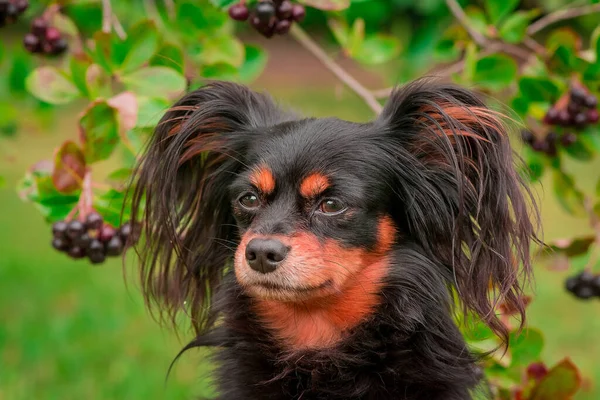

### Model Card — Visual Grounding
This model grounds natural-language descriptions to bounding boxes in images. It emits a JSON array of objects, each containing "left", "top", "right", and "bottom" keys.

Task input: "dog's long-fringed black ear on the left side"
[{"left": 132, "top": 82, "right": 291, "bottom": 332}]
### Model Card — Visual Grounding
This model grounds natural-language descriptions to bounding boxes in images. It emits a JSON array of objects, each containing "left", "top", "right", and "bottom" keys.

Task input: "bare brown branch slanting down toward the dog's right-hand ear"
[{"left": 290, "top": 24, "right": 383, "bottom": 114}]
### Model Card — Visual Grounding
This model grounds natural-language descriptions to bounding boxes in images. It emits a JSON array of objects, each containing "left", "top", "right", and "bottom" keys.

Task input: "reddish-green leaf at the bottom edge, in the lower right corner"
[{"left": 530, "top": 359, "right": 581, "bottom": 400}]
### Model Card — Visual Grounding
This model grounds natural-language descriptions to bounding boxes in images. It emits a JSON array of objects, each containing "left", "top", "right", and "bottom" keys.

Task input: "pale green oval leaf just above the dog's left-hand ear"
[{"left": 122, "top": 67, "right": 186, "bottom": 98}]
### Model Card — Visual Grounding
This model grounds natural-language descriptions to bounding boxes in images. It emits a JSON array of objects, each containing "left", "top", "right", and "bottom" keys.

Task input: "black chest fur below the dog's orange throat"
[{"left": 208, "top": 266, "right": 478, "bottom": 400}]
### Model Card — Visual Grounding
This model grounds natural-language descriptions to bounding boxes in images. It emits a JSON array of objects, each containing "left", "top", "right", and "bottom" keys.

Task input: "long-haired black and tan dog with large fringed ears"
[{"left": 132, "top": 79, "right": 536, "bottom": 400}]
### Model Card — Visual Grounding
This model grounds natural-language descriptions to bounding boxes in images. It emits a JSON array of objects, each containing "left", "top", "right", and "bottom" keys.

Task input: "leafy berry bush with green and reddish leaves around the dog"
[{"left": 0, "top": 0, "right": 600, "bottom": 400}]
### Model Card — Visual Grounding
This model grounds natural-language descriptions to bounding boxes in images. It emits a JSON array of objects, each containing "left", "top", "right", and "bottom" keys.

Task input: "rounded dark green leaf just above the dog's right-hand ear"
[{"left": 473, "top": 54, "right": 517, "bottom": 90}]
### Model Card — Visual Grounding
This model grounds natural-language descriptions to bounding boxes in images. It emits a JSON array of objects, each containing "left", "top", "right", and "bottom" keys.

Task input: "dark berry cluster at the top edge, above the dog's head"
[{"left": 229, "top": 0, "right": 306, "bottom": 38}]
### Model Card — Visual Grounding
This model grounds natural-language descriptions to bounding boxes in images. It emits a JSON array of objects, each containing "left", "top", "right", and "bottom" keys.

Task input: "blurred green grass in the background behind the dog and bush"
[{"left": 0, "top": 88, "right": 600, "bottom": 400}]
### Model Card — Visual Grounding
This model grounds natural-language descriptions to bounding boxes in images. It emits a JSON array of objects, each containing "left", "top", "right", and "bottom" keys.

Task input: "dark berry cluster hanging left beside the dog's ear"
[{"left": 52, "top": 213, "right": 137, "bottom": 264}]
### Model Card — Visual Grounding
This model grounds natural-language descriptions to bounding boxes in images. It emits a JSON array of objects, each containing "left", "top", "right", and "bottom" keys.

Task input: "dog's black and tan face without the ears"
[{"left": 229, "top": 119, "right": 396, "bottom": 302}]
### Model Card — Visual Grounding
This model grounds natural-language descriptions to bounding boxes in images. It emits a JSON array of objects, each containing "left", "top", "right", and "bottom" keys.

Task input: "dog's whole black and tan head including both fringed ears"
[{"left": 134, "top": 81, "right": 535, "bottom": 344}]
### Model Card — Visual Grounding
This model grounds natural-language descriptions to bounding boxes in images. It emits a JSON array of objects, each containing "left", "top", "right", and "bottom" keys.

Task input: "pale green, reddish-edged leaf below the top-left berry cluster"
[{"left": 25, "top": 67, "right": 79, "bottom": 104}]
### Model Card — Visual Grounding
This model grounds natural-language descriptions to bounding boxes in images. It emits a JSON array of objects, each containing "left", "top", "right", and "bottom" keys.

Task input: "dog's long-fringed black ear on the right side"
[{"left": 376, "top": 81, "right": 536, "bottom": 339}]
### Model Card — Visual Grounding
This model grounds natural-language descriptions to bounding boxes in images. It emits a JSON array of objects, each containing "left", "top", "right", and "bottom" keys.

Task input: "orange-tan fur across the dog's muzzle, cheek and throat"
[{"left": 235, "top": 216, "right": 396, "bottom": 350}]
